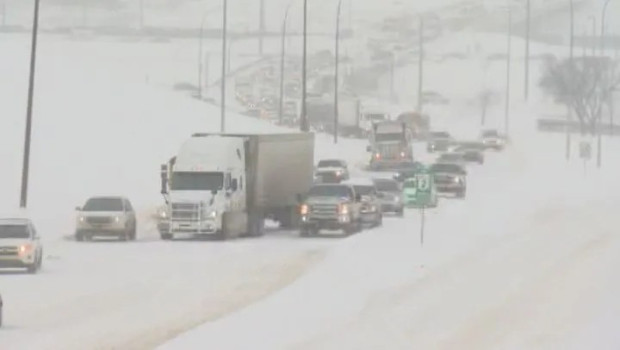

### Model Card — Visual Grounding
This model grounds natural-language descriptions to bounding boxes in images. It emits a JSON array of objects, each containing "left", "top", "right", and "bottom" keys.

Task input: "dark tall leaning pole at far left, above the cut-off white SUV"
[{"left": 19, "top": 0, "right": 40, "bottom": 208}]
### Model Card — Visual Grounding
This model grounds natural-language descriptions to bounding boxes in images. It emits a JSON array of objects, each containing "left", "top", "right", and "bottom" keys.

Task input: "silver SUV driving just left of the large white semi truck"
[{"left": 75, "top": 197, "right": 137, "bottom": 241}]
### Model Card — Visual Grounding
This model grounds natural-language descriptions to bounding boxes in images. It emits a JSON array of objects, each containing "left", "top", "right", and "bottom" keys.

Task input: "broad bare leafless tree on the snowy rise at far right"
[{"left": 540, "top": 57, "right": 620, "bottom": 136}]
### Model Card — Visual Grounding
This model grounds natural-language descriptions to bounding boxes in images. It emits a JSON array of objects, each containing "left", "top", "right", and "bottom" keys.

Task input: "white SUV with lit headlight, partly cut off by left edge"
[{"left": 0, "top": 218, "right": 43, "bottom": 273}]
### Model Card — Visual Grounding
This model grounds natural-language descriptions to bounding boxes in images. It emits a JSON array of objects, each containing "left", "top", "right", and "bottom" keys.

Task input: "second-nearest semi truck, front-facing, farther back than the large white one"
[{"left": 367, "top": 121, "right": 413, "bottom": 170}]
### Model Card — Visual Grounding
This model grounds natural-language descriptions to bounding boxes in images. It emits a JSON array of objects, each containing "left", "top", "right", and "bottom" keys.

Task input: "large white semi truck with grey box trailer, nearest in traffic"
[{"left": 158, "top": 133, "right": 314, "bottom": 240}]
